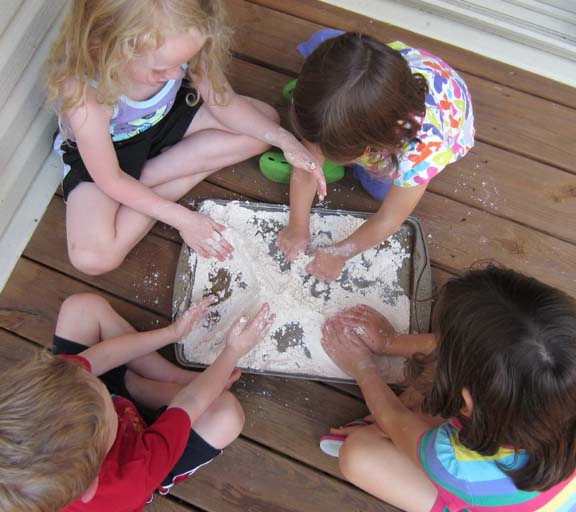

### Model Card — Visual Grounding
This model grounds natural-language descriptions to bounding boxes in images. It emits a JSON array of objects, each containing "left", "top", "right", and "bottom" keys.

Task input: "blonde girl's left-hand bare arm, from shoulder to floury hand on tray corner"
[{"left": 70, "top": 88, "right": 232, "bottom": 259}]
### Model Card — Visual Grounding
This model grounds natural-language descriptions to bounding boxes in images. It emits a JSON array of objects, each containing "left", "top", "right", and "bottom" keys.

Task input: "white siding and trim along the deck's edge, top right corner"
[{"left": 323, "top": 0, "right": 576, "bottom": 86}]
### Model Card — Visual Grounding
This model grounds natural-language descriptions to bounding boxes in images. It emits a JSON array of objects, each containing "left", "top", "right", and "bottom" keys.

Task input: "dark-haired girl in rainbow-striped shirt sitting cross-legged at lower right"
[{"left": 321, "top": 267, "right": 576, "bottom": 512}]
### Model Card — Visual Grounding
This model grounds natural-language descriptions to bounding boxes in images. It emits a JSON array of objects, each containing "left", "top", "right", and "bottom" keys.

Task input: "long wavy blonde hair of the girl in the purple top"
[{"left": 46, "top": 0, "right": 230, "bottom": 132}]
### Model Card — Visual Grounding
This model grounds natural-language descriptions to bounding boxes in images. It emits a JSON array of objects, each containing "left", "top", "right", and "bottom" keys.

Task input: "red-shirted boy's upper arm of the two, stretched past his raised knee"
[{"left": 81, "top": 297, "right": 215, "bottom": 375}]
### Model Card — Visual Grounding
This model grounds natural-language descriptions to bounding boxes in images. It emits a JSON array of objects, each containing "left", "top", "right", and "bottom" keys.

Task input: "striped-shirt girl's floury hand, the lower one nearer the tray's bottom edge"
[{"left": 322, "top": 317, "right": 375, "bottom": 380}]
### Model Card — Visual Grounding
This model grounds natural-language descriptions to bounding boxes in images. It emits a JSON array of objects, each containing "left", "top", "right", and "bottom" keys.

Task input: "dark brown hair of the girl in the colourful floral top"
[{"left": 291, "top": 32, "right": 428, "bottom": 165}]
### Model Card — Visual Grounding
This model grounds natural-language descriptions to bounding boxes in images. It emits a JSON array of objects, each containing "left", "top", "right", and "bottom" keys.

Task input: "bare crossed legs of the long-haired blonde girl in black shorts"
[{"left": 66, "top": 95, "right": 278, "bottom": 275}]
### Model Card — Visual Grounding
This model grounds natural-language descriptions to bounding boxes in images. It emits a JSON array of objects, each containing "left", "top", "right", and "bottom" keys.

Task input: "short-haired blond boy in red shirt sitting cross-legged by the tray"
[{"left": 0, "top": 294, "right": 274, "bottom": 512}]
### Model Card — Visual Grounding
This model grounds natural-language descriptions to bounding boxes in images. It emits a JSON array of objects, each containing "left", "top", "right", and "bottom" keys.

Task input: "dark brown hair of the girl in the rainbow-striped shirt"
[{"left": 424, "top": 266, "right": 576, "bottom": 491}]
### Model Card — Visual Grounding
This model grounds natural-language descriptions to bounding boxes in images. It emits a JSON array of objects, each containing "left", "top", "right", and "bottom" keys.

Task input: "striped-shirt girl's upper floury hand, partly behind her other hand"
[{"left": 336, "top": 304, "right": 397, "bottom": 354}]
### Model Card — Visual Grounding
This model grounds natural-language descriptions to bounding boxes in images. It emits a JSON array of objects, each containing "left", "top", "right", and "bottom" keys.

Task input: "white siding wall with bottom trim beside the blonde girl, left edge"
[{"left": 0, "top": 0, "right": 66, "bottom": 290}]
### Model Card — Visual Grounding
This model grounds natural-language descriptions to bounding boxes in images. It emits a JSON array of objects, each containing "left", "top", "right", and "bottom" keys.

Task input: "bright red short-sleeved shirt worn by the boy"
[{"left": 62, "top": 356, "right": 191, "bottom": 512}]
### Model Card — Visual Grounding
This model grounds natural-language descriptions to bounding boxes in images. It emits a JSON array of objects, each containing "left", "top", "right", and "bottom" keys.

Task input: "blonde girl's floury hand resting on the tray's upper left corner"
[{"left": 179, "top": 212, "right": 234, "bottom": 261}]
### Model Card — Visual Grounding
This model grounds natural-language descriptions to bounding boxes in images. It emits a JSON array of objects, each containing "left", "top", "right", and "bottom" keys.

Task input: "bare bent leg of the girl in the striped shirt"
[{"left": 339, "top": 425, "right": 438, "bottom": 512}]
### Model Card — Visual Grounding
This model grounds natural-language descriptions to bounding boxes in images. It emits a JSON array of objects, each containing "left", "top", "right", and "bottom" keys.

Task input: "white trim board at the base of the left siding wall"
[{"left": 0, "top": 152, "right": 62, "bottom": 292}]
